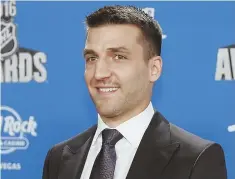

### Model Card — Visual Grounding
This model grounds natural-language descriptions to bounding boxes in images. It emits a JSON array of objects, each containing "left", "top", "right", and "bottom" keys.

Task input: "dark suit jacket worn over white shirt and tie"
[{"left": 43, "top": 112, "right": 227, "bottom": 179}]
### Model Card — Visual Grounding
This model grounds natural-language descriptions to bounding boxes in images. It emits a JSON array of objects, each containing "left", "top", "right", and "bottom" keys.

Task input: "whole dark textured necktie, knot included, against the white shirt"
[{"left": 90, "top": 129, "right": 123, "bottom": 179}]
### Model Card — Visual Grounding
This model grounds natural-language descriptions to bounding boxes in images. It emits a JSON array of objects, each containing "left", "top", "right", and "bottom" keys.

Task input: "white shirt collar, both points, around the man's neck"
[{"left": 92, "top": 102, "right": 154, "bottom": 148}]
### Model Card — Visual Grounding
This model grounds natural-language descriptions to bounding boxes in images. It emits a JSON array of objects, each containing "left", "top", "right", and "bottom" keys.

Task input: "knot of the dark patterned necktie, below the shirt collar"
[{"left": 102, "top": 129, "right": 123, "bottom": 145}]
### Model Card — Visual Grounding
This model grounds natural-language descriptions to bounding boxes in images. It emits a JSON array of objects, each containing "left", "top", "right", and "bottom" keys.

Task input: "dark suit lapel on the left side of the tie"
[{"left": 58, "top": 126, "right": 96, "bottom": 179}]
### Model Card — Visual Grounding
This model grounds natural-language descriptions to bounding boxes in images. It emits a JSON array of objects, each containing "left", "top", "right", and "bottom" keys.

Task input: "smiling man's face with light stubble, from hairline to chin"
[{"left": 84, "top": 25, "right": 155, "bottom": 118}]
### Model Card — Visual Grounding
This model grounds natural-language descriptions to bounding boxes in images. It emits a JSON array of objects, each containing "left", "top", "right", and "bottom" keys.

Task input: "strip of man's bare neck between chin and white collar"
[{"left": 100, "top": 101, "right": 150, "bottom": 128}]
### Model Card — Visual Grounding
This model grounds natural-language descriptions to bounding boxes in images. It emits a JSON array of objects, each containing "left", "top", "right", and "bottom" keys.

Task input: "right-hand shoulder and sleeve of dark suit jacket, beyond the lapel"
[{"left": 166, "top": 124, "right": 227, "bottom": 179}]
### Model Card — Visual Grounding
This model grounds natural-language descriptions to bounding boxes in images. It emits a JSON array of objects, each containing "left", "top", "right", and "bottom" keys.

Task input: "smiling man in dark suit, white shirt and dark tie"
[{"left": 43, "top": 6, "right": 227, "bottom": 179}]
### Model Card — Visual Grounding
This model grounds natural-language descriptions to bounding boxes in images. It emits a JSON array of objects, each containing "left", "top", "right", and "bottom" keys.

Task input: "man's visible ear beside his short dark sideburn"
[{"left": 148, "top": 56, "right": 162, "bottom": 83}]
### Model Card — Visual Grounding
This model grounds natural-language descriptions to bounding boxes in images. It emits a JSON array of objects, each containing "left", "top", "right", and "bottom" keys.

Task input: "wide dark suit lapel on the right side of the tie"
[{"left": 126, "top": 112, "right": 179, "bottom": 179}]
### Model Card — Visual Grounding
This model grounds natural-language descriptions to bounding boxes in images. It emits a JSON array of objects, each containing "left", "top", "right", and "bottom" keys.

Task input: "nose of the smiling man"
[{"left": 95, "top": 59, "right": 111, "bottom": 80}]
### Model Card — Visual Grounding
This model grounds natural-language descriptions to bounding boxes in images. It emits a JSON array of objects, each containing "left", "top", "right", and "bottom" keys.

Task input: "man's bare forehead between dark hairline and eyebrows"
[{"left": 85, "top": 25, "right": 142, "bottom": 50}]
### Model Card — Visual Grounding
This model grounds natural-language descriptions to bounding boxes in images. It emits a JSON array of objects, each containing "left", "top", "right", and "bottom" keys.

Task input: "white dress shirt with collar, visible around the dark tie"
[{"left": 81, "top": 102, "right": 154, "bottom": 179}]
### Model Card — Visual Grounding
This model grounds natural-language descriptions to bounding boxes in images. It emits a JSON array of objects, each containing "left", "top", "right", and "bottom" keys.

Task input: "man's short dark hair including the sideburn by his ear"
[{"left": 86, "top": 5, "right": 162, "bottom": 58}]
